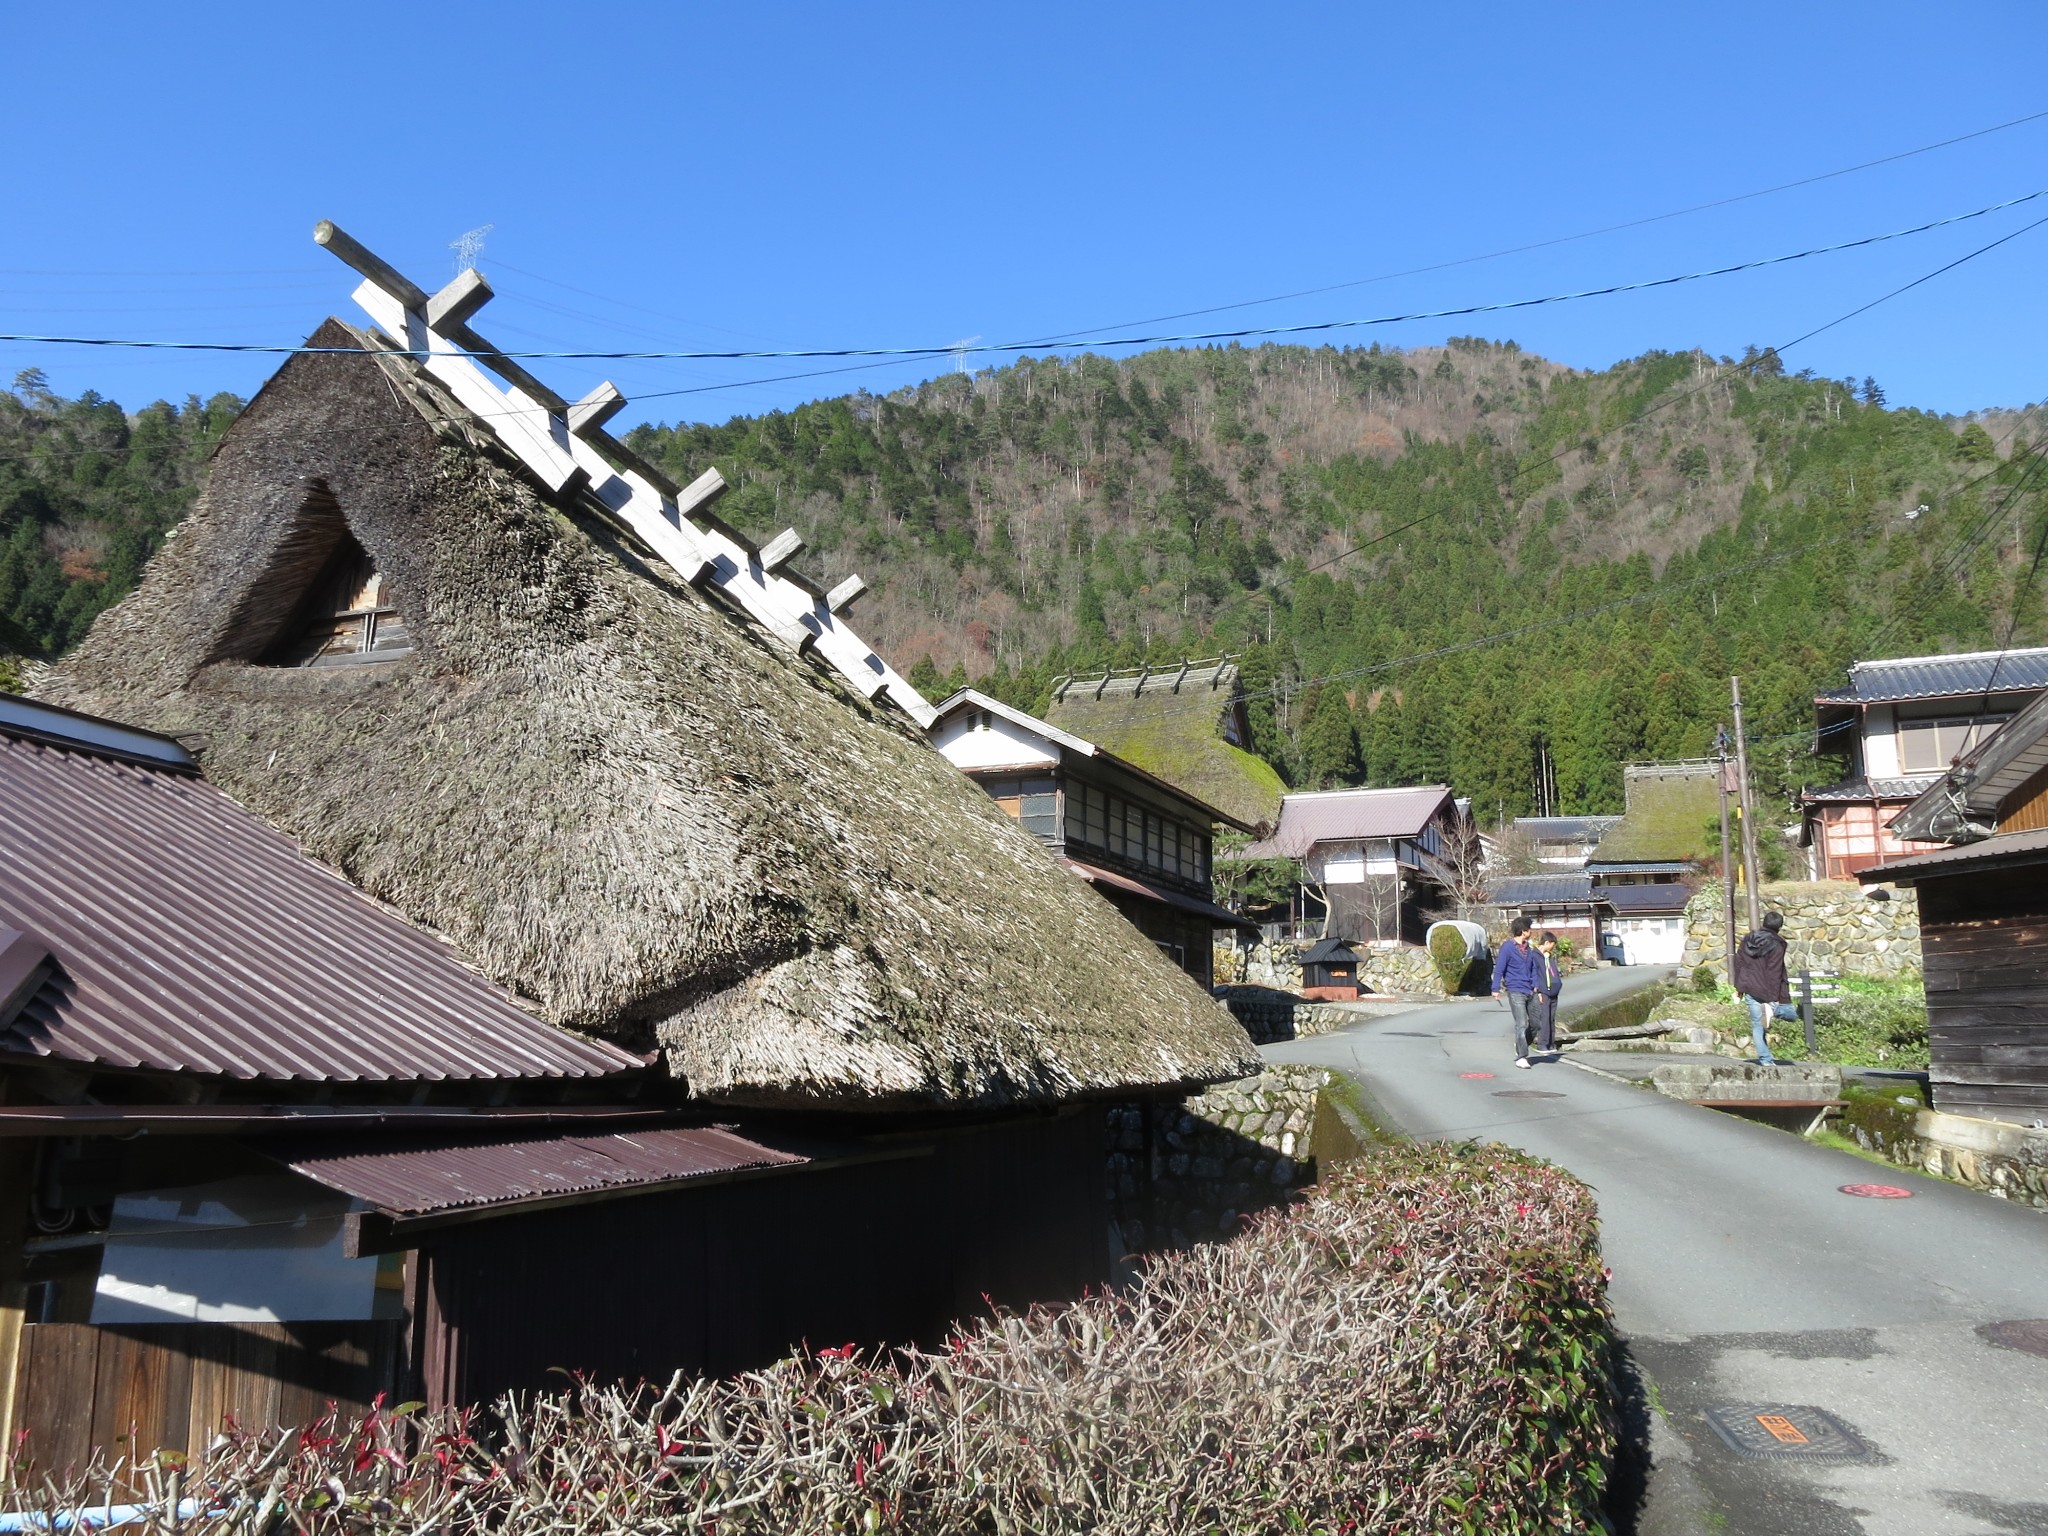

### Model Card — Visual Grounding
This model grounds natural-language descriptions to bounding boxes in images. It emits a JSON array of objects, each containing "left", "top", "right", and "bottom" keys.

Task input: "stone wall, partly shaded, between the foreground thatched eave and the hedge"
[{"left": 1108, "top": 1065, "right": 1335, "bottom": 1253}]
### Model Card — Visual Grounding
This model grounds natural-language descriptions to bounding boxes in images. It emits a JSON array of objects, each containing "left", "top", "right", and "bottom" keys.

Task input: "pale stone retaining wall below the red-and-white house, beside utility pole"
[{"left": 1681, "top": 881, "right": 1921, "bottom": 979}]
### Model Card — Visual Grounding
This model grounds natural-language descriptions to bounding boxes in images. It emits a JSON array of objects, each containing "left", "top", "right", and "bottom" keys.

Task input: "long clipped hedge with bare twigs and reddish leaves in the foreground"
[{"left": 14, "top": 1145, "right": 1614, "bottom": 1536}]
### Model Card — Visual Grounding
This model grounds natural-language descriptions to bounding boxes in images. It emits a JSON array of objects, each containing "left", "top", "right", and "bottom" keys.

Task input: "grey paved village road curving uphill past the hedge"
[{"left": 1264, "top": 971, "right": 2048, "bottom": 1536}]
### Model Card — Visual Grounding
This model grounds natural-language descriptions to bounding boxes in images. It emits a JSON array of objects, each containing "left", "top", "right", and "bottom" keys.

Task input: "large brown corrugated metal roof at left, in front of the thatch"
[{"left": 0, "top": 700, "right": 641, "bottom": 1081}]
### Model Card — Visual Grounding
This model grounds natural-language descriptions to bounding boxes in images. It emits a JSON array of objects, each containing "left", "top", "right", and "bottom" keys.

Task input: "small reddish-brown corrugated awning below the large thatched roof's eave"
[{"left": 287, "top": 1126, "right": 811, "bottom": 1219}]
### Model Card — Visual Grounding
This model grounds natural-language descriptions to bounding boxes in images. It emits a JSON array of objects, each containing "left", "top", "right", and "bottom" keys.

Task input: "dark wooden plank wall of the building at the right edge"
[{"left": 1919, "top": 866, "right": 2048, "bottom": 1120}]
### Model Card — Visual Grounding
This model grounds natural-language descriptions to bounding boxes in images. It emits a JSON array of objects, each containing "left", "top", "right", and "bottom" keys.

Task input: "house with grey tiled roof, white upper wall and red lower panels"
[{"left": 1800, "top": 647, "right": 2048, "bottom": 881}]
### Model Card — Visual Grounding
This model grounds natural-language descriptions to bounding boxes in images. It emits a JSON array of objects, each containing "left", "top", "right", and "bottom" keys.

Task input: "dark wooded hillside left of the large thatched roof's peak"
[{"left": 0, "top": 369, "right": 242, "bottom": 686}]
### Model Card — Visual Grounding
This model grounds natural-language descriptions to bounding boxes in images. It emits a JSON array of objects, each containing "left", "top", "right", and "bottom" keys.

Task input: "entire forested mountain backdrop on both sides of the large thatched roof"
[{"left": 0, "top": 340, "right": 2048, "bottom": 817}]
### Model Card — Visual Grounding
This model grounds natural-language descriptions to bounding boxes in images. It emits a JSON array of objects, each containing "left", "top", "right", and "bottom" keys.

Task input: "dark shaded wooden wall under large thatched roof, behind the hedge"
[{"left": 418, "top": 1108, "right": 1108, "bottom": 1403}]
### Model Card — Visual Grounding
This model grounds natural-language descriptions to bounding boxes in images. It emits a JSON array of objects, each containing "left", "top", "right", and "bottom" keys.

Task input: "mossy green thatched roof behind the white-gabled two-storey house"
[{"left": 1044, "top": 657, "right": 1286, "bottom": 831}]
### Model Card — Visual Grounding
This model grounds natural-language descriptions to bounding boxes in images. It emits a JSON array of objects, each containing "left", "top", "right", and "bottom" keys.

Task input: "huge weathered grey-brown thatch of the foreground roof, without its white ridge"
[{"left": 43, "top": 322, "right": 1255, "bottom": 1106}]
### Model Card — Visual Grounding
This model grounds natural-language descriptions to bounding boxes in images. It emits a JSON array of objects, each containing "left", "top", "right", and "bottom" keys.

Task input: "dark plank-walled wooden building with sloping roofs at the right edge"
[{"left": 1860, "top": 694, "right": 2048, "bottom": 1124}]
